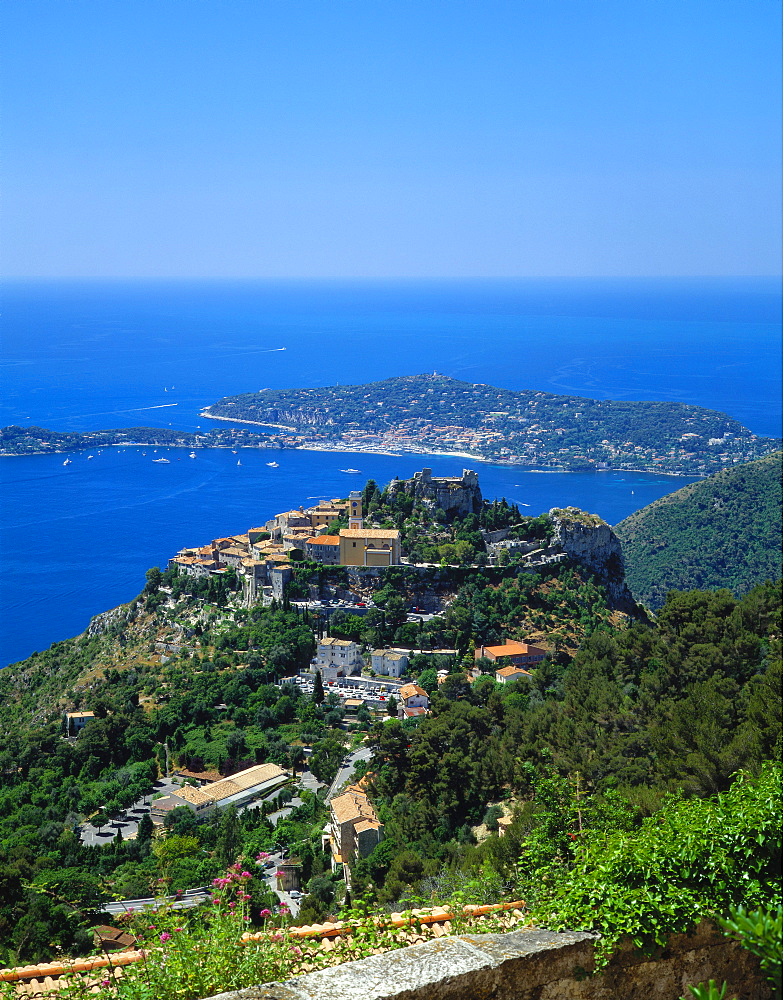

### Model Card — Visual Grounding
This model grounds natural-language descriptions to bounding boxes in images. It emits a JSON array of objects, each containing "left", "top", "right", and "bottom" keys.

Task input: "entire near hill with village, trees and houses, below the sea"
[{"left": 0, "top": 460, "right": 781, "bottom": 982}]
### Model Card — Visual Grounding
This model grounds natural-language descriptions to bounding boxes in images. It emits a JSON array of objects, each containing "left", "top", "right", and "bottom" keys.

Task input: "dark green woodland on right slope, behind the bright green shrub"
[{"left": 357, "top": 584, "right": 781, "bottom": 901}]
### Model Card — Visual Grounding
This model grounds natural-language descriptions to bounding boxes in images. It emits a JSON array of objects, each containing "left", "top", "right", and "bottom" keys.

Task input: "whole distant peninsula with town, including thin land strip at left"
[{"left": 0, "top": 373, "right": 781, "bottom": 476}]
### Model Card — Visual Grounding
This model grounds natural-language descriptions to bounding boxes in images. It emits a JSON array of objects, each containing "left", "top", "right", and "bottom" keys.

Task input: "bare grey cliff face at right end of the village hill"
[{"left": 550, "top": 507, "right": 637, "bottom": 610}]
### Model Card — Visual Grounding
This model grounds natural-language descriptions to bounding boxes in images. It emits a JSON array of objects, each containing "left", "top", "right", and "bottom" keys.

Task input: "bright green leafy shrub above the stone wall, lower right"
[{"left": 526, "top": 763, "right": 781, "bottom": 962}]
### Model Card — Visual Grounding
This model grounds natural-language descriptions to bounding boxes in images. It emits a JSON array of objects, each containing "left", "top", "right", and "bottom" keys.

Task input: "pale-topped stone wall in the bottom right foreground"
[{"left": 204, "top": 923, "right": 772, "bottom": 1000}]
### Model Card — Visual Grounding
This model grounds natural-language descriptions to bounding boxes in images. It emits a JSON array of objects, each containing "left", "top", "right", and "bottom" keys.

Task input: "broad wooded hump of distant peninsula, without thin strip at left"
[{"left": 205, "top": 375, "right": 777, "bottom": 474}]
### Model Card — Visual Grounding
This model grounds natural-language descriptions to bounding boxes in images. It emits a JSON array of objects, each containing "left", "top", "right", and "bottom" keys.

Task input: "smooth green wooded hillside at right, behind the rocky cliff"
[{"left": 615, "top": 452, "right": 781, "bottom": 609}]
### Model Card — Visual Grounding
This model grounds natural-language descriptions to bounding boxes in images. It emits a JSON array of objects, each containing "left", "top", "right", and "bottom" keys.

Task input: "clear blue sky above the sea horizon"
[{"left": 0, "top": 0, "right": 781, "bottom": 278}]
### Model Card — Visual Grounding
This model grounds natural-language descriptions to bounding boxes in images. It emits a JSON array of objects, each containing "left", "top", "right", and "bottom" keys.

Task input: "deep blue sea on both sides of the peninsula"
[{"left": 0, "top": 279, "right": 781, "bottom": 665}]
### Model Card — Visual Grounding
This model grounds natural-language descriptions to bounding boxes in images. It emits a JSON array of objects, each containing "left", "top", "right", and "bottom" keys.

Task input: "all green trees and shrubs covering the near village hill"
[{"left": 0, "top": 472, "right": 782, "bottom": 980}]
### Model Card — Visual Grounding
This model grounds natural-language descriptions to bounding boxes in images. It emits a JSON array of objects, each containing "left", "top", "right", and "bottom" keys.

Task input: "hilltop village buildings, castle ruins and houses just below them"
[{"left": 169, "top": 468, "right": 552, "bottom": 700}]
